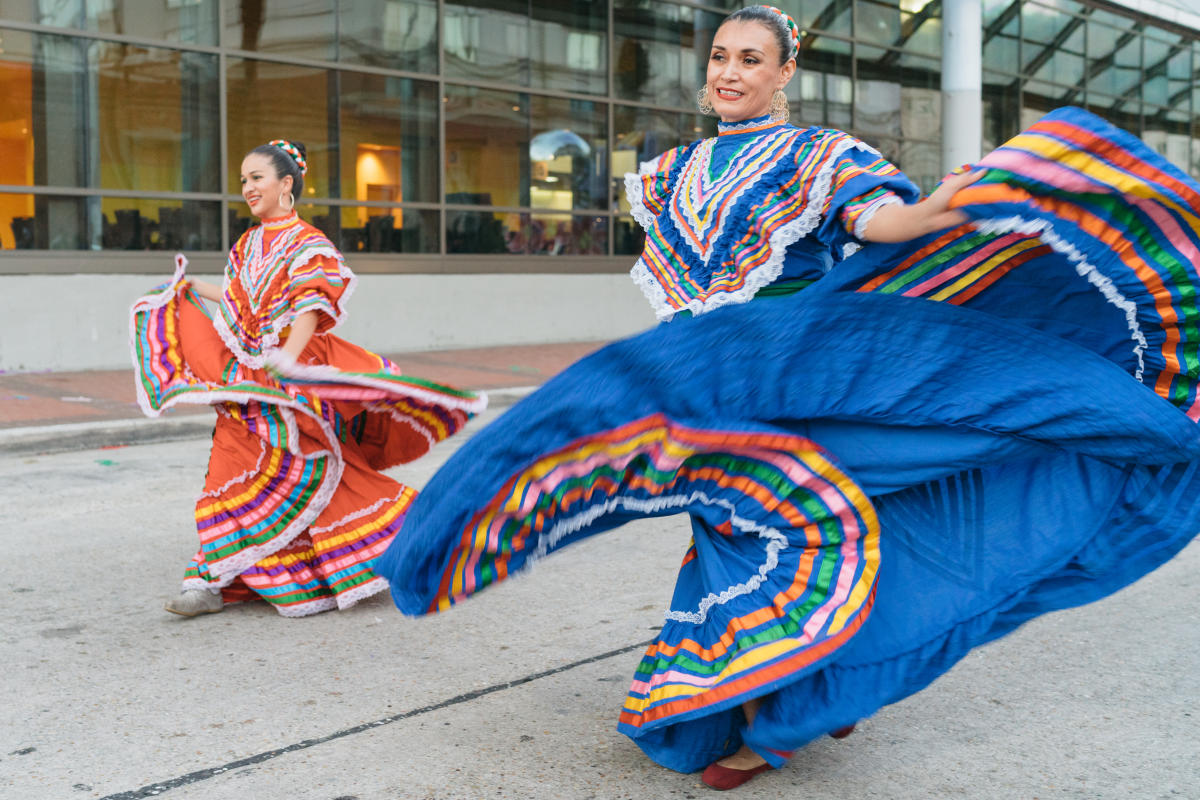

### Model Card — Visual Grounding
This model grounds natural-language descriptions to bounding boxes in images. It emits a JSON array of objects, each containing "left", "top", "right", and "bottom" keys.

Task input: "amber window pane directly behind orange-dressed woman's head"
[{"left": 227, "top": 59, "right": 337, "bottom": 197}]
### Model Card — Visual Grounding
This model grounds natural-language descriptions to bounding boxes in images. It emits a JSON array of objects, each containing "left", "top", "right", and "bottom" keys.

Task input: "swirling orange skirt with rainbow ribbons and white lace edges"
[{"left": 132, "top": 266, "right": 486, "bottom": 616}]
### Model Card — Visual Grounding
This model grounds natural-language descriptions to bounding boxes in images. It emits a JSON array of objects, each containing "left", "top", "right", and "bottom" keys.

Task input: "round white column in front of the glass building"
[{"left": 942, "top": 0, "right": 983, "bottom": 173}]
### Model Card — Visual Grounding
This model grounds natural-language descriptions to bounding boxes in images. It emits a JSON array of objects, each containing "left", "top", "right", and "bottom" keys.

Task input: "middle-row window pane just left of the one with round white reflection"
[{"left": 443, "top": 86, "right": 529, "bottom": 209}]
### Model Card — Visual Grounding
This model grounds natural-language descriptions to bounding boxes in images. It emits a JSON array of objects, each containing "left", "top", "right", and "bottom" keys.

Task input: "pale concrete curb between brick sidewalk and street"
[{"left": 0, "top": 386, "right": 538, "bottom": 457}]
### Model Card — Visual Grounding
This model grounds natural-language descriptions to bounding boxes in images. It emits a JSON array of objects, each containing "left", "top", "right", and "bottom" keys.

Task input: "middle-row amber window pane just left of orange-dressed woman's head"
[{"left": 97, "top": 42, "right": 221, "bottom": 192}]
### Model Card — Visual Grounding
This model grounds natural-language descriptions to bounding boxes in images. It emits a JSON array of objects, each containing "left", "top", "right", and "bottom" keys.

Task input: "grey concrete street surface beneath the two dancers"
[{"left": 0, "top": 410, "right": 1200, "bottom": 800}]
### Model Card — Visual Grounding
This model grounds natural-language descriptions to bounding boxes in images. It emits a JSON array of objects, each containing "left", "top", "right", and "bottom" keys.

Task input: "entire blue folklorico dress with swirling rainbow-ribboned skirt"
[{"left": 377, "top": 109, "right": 1200, "bottom": 771}]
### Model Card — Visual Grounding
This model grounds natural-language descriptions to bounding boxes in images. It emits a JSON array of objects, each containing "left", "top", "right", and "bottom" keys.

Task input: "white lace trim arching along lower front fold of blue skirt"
[{"left": 522, "top": 492, "right": 787, "bottom": 625}]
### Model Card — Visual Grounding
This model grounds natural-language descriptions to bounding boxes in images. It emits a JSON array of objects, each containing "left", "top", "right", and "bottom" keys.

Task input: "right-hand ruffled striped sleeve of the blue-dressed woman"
[{"left": 815, "top": 137, "right": 920, "bottom": 260}]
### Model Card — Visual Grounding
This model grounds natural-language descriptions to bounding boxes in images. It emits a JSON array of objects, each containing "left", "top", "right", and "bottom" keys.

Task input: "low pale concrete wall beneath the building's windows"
[{"left": 0, "top": 275, "right": 654, "bottom": 372}]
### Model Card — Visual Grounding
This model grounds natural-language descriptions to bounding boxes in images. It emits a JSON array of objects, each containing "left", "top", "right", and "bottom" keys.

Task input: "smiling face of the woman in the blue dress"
[{"left": 706, "top": 20, "right": 796, "bottom": 122}]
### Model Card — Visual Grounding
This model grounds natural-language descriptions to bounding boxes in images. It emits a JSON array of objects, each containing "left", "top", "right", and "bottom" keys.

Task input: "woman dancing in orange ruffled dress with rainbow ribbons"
[{"left": 132, "top": 139, "right": 486, "bottom": 616}]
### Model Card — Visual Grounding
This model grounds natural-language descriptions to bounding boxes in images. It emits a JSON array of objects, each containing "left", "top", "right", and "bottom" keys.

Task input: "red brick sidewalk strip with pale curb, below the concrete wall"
[{"left": 0, "top": 342, "right": 604, "bottom": 452}]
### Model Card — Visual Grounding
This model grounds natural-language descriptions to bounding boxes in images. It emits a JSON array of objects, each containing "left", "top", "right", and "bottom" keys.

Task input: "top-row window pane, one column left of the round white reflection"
[{"left": 443, "top": 0, "right": 530, "bottom": 86}]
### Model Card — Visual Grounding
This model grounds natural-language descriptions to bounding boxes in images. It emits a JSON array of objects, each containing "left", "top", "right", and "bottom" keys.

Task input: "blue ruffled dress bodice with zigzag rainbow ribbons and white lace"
[{"left": 625, "top": 116, "right": 919, "bottom": 319}]
